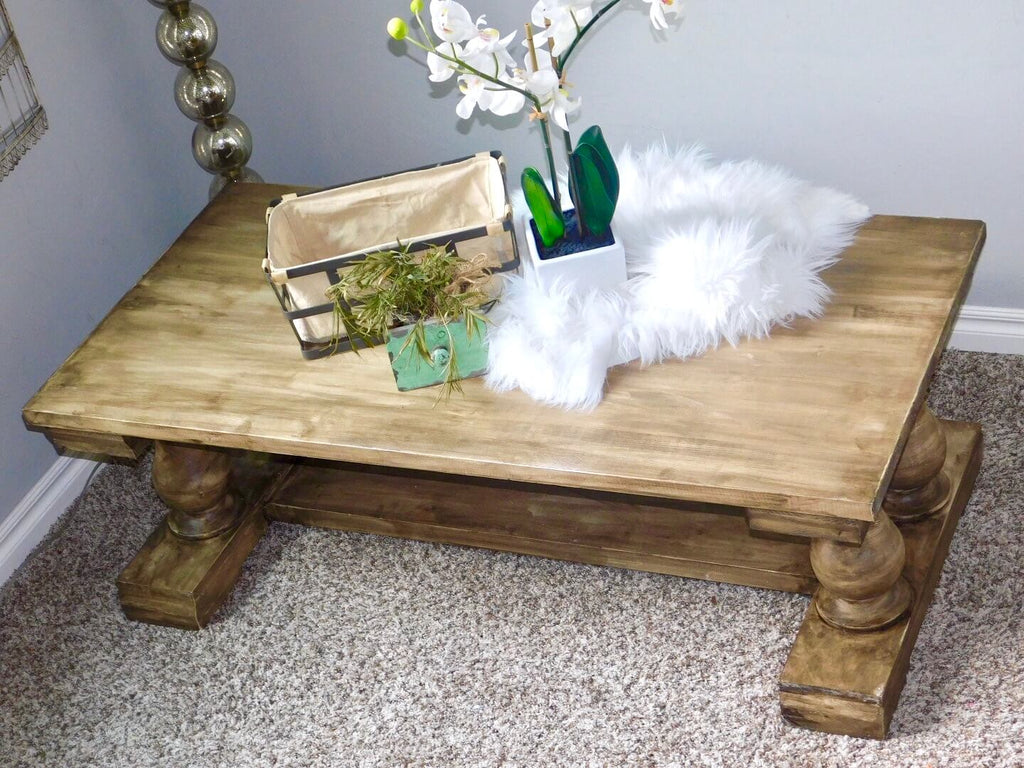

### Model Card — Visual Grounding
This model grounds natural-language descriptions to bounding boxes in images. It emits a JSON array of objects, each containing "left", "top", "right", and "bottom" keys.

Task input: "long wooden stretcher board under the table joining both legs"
[{"left": 265, "top": 465, "right": 817, "bottom": 594}]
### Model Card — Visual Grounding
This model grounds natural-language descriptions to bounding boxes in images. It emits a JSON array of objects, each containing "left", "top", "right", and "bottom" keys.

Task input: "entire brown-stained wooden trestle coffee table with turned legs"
[{"left": 25, "top": 184, "right": 985, "bottom": 738}]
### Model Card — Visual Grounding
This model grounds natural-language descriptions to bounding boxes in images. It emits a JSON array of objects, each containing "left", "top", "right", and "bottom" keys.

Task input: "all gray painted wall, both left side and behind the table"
[{"left": 0, "top": 0, "right": 1024, "bottom": 528}]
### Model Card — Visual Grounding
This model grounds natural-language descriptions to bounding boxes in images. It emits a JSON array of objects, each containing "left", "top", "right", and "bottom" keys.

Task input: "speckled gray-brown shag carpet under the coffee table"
[{"left": 0, "top": 352, "right": 1024, "bottom": 768}]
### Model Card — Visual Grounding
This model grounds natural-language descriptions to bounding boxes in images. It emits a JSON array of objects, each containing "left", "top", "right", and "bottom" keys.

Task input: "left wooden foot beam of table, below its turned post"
[{"left": 118, "top": 506, "right": 266, "bottom": 630}]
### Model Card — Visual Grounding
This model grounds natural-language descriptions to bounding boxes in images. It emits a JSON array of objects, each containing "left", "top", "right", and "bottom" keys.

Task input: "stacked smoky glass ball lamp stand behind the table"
[{"left": 150, "top": 0, "right": 263, "bottom": 199}]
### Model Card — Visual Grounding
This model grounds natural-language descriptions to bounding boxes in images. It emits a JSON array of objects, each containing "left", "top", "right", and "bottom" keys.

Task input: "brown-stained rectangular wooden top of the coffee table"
[{"left": 24, "top": 184, "right": 985, "bottom": 520}]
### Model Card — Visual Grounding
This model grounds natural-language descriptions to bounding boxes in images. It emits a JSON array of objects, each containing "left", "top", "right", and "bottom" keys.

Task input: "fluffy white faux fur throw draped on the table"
[{"left": 486, "top": 144, "right": 869, "bottom": 410}]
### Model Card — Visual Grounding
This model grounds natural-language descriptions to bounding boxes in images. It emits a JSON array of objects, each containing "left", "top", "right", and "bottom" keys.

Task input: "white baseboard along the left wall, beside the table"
[{"left": 0, "top": 456, "right": 96, "bottom": 585}]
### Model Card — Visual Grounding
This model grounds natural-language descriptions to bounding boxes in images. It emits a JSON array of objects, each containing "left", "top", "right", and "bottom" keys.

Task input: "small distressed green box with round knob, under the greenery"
[{"left": 387, "top": 321, "right": 487, "bottom": 392}]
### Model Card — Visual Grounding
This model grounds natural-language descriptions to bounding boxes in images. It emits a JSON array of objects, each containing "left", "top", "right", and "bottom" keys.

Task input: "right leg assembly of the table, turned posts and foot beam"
[{"left": 779, "top": 415, "right": 981, "bottom": 738}]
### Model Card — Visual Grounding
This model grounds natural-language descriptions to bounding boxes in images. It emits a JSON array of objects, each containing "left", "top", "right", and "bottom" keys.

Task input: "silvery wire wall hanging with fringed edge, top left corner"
[{"left": 0, "top": 0, "right": 47, "bottom": 179}]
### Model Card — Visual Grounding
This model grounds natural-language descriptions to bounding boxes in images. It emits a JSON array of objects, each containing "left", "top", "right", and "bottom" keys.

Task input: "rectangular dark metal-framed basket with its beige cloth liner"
[{"left": 263, "top": 152, "right": 519, "bottom": 357}]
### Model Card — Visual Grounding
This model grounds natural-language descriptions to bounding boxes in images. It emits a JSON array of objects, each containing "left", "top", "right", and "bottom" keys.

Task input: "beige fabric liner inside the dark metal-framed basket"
[{"left": 267, "top": 154, "right": 513, "bottom": 342}]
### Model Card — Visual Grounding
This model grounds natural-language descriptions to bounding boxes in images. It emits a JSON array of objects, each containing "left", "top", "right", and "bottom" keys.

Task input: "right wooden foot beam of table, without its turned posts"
[{"left": 779, "top": 422, "right": 981, "bottom": 739}]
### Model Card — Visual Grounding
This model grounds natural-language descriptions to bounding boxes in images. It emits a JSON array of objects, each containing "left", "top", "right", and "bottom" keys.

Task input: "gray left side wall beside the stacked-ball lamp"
[{"left": 0, "top": 0, "right": 209, "bottom": 519}]
